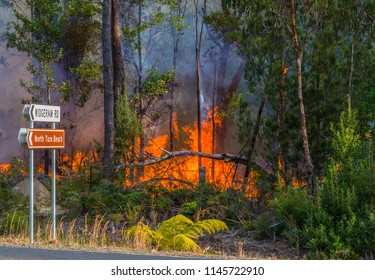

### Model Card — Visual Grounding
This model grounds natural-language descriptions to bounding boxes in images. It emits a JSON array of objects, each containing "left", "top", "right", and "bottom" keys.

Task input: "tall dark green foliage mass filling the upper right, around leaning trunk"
[{"left": 216, "top": 0, "right": 375, "bottom": 179}]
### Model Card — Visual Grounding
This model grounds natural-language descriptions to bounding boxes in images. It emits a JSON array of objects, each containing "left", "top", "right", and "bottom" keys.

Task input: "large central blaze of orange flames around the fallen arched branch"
[{"left": 124, "top": 107, "right": 259, "bottom": 198}]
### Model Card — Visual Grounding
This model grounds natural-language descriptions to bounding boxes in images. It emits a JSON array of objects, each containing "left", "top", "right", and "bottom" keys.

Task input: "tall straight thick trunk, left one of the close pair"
[{"left": 102, "top": 0, "right": 115, "bottom": 180}]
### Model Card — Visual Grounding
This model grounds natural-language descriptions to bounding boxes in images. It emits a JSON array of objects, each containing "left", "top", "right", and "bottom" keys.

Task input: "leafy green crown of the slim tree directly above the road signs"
[{"left": 6, "top": 0, "right": 63, "bottom": 103}]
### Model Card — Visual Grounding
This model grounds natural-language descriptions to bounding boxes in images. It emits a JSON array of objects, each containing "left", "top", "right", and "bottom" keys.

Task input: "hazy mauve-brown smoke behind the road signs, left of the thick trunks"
[{"left": 0, "top": 9, "right": 103, "bottom": 163}]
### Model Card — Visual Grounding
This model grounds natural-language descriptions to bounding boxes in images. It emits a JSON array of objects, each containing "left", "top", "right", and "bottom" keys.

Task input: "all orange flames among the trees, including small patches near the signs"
[{"left": 19, "top": 106, "right": 259, "bottom": 198}]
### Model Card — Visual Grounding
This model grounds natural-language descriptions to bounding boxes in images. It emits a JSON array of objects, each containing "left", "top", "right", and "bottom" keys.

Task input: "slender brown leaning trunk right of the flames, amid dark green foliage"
[{"left": 290, "top": 0, "right": 316, "bottom": 195}]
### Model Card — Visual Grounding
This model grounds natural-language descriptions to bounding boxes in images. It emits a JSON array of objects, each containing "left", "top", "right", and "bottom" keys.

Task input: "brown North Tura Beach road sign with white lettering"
[{"left": 26, "top": 128, "right": 65, "bottom": 149}]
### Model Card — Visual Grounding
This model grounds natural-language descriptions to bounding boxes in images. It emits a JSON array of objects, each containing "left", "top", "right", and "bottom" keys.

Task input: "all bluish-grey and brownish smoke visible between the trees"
[{"left": 0, "top": 0, "right": 250, "bottom": 163}]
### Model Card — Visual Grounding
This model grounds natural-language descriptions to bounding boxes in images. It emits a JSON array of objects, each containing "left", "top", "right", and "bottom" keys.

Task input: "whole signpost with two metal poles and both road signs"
[{"left": 18, "top": 104, "right": 65, "bottom": 244}]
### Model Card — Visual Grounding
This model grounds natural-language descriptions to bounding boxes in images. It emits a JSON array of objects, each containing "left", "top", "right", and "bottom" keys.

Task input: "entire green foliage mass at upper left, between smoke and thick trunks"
[{"left": 6, "top": 0, "right": 100, "bottom": 106}]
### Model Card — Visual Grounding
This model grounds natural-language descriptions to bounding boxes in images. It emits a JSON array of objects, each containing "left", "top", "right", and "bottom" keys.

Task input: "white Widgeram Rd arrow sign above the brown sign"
[{"left": 23, "top": 104, "right": 60, "bottom": 122}]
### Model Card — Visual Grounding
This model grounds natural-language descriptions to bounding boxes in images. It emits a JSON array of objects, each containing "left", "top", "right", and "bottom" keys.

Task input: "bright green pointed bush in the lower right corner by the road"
[{"left": 300, "top": 104, "right": 375, "bottom": 259}]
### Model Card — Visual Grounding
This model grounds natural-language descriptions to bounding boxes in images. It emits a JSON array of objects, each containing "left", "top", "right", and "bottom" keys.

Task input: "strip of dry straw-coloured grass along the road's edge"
[{"left": 0, "top": 213, "right": 301, "bottom": 259}]
